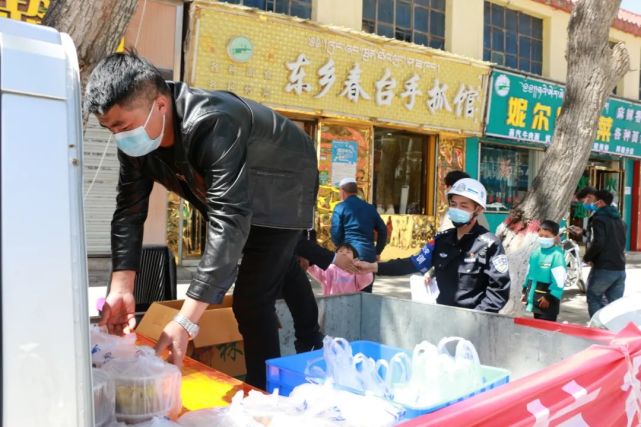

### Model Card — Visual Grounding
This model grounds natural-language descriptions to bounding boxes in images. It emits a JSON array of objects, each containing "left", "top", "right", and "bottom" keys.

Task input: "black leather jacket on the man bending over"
[{"left": 111, "top": 82, "right": 318, "bottom": 303}]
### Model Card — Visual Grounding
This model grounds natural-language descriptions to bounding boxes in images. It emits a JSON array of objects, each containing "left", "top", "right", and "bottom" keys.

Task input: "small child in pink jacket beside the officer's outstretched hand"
[{"left": 307, "top": 243, "right": 374, "bottom": 296}]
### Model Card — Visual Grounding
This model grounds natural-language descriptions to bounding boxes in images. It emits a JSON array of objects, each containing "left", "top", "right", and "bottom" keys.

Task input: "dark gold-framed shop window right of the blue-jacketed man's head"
[{"left": 374, "top": 129, "right": 427, "bottom": 214}]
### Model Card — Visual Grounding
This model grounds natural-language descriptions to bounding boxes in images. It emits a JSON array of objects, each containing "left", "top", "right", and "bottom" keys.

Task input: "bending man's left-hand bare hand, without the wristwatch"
[{"left": 100, "top": 271, "right": 136, "bottom": 335}]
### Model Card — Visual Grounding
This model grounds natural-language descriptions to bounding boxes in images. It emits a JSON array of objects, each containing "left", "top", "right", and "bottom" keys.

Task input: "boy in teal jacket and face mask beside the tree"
[{"left": 521, "top": 220, "right": 567, "bottom": 322}]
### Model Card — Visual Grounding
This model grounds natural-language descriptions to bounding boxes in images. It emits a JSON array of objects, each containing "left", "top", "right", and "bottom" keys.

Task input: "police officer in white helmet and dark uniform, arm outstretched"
[{"left": 358, "top": 178, "right": 510, "bottom": 313}]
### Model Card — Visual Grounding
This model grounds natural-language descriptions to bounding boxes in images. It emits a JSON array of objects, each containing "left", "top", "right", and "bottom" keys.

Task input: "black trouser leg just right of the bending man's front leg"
[{"left": 282, "top": 257, "right": 324, "bottom": 353}]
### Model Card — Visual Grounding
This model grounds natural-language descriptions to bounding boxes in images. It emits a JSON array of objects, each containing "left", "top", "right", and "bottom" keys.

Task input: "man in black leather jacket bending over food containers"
[{"left": 85, "top": 53, "right": 318, "bottom": 388}]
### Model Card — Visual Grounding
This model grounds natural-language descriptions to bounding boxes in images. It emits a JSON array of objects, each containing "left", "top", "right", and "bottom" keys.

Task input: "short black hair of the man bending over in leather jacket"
[{"left": 84, "top": 51, "right": 169, "bottom": 114}]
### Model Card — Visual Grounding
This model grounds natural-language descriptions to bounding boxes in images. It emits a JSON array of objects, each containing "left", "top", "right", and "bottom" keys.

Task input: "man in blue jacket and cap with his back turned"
[{"left": 330, "top": 178, "right": 387, "bottom": 293}]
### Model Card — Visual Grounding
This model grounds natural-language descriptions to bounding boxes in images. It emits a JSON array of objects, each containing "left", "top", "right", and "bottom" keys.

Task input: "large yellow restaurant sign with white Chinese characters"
[{"left": 185, "top": 0, "right": 489, "bottom": 134}]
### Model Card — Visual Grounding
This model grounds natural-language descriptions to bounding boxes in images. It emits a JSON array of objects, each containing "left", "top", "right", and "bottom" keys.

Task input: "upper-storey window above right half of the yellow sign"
[{"left": 362, "top": 0, "right": 445, "bottom": 49}]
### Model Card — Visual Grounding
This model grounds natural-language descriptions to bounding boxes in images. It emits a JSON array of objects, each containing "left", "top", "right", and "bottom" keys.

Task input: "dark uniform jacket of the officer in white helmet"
[{"left": 378, "top": 224, "right": 510, "bottom": 313}]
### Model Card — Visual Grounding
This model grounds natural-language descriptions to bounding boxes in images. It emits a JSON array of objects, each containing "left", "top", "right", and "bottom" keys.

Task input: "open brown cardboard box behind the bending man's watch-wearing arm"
[{"left": 136, "top": 295, "right": 246, "bottom": 377}]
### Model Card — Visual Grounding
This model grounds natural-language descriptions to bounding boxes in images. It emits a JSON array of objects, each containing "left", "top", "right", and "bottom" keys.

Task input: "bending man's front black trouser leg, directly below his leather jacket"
[{"left": 233, "top": 226, "right": 300, "bottom": 389}]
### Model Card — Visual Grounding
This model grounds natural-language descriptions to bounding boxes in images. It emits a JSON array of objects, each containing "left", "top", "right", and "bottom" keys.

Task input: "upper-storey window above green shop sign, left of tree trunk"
[{"left": 483, "top": 1, "right": 543, "bottom": 74}]
